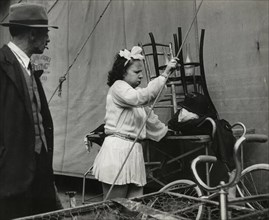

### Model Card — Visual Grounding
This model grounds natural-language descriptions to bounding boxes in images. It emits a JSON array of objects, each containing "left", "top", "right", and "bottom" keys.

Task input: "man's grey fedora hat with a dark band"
[{"left": 0, "top": 3, "right": 58, "bottom": 28}]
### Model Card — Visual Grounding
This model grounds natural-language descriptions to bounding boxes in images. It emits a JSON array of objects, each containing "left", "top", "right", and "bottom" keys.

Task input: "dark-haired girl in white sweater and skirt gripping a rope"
[{"left": 93, "top": 46, "right": 177, "bottom": 199}]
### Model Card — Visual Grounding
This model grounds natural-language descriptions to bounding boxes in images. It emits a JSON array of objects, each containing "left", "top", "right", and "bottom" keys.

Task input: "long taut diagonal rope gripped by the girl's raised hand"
[{"left": 104, "top": 0, "right": 203, "bottom": 201}]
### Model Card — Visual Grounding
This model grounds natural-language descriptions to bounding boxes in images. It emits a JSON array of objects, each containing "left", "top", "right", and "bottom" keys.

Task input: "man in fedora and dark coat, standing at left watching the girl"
[{"left": 0, "top": 3, "right": 61, "bottom": 220}]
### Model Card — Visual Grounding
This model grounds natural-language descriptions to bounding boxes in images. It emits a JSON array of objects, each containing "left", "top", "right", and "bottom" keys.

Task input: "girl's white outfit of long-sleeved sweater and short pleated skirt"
[{"left": 93, "top": 76, "right": 168, "bottom": 186}]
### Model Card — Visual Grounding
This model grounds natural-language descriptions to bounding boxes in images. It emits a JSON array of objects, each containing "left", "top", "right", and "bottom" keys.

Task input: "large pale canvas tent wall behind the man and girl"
[{"left": 0, "top": 0, "right": 269, "bottom": 176}]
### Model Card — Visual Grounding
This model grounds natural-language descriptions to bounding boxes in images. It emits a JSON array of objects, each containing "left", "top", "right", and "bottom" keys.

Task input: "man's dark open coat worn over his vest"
[{"left": 0, "top": 45, "right": 53, "bottom": 198}]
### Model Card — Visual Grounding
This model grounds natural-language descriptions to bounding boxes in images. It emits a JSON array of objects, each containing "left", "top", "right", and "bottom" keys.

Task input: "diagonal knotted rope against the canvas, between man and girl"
[{"left": 48, "top": 0, "right": 112, "bottom": 103}]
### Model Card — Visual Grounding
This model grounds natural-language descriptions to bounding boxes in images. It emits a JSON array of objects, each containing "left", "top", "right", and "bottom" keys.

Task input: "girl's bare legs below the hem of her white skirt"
[{"left": 102, "top": 183, "right": 128, "bottom": 199}]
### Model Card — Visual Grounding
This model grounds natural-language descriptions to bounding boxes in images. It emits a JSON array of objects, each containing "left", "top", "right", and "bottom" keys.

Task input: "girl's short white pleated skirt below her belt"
[{"left": 93, "top": 136, "right": 146, "bottom": 186}]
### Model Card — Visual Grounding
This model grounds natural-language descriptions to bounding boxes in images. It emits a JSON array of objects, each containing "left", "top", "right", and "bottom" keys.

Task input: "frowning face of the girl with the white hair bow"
[{"left": 123, "top": 60, "right": 143, "bottom": 88}]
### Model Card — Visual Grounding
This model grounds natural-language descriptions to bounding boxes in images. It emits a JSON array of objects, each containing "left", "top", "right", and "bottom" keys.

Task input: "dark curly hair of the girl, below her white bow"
[{"left": 107, "top": 54, "right": 133, "bottom": 87}]
